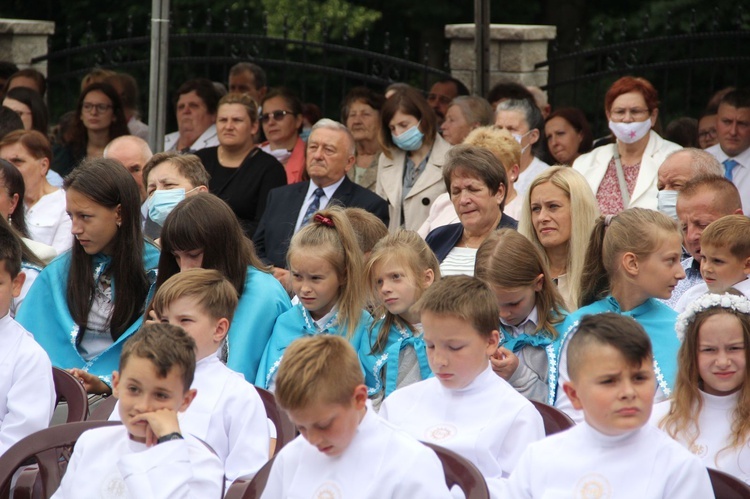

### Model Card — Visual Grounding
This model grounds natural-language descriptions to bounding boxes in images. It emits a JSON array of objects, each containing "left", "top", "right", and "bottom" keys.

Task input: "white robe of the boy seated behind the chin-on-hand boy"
[{"left": 110, "top": 355, "right": 270, "bottom": 488}]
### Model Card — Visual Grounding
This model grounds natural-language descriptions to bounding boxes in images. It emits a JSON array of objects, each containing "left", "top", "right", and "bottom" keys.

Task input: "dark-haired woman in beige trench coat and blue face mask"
[{"left": 375, "top": 88, "right": 451, "bottom": 230}]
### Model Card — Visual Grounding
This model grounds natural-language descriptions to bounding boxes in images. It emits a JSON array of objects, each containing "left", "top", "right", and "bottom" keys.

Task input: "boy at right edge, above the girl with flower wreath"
[{"left": 675, "top": 215, "right": 750, "bottom": 312}]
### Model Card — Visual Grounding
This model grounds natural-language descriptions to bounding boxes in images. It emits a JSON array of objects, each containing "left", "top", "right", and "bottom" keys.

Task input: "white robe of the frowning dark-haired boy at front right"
[{"left": 505, "top": 423, "right": 714, "bottom": 499}]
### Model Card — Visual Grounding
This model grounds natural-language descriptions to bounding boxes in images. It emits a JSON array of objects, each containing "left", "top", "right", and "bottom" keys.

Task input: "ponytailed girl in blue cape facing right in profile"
[{"left": 555, "top": 208, "right": 685, "bottom": 422}]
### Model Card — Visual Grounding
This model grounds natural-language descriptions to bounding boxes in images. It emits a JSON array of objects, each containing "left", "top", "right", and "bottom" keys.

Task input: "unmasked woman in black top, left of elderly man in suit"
[{"left": 196, "top": 94, "right": 287, "bottom": 237}]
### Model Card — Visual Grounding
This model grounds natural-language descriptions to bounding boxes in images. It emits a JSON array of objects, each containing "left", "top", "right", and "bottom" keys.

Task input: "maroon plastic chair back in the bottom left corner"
[{"left": 0, "top": 421, "right": 120, "bottom": 498}]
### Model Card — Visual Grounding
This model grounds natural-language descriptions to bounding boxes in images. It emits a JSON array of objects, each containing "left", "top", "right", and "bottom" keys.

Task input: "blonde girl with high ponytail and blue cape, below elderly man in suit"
[{"left": 255, "top": 207, "right": 372, "bottom": 389}]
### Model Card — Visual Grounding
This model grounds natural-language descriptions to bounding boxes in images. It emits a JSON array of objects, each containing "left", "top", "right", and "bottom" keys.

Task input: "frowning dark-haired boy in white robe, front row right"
[{"left": 506, "top": 313, "right": 714, "bottom": 499}]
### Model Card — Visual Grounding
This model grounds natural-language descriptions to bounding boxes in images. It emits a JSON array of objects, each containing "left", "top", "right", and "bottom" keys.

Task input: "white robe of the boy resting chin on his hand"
[{"left": 52, "top": 426, "right": 224, "bottom": 499}]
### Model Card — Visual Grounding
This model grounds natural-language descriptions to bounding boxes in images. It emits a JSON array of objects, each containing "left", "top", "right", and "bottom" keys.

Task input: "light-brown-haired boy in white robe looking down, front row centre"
[{"left": 261, "top": 334, "right": 451, "bottom": 499}]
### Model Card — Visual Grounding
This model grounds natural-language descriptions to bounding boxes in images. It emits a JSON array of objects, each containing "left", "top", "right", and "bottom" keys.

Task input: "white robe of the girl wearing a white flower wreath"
[{"left": 651, "top": 392, "right": 750, "bottom": 485}]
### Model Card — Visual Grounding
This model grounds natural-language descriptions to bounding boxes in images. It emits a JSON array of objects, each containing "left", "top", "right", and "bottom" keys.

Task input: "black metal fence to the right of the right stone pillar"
[{"left": 537, "top": 10, "right": 750, "bottom": 137}]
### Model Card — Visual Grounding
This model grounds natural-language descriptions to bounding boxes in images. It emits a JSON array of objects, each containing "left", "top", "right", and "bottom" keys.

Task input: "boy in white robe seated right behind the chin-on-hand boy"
[{"left": 111, "top": 269, "right": 270, "bottom": 488}]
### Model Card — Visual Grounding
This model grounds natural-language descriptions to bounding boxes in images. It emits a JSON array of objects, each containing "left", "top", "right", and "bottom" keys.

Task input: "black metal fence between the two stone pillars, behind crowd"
[{"left": 32, "top": 10, "right": 449, "bottom": 129}]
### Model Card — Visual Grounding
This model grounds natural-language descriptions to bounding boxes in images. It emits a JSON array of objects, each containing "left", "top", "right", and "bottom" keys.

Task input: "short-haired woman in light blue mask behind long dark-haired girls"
[{"left": 143, "top": 151, "right": 210, "bottom": 239}]
